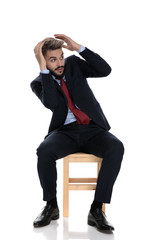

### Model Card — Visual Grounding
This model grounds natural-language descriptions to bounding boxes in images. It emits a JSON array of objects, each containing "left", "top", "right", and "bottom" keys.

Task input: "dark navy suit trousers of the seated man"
[{"left": 37, "top": 122, "right": 124, "bottom": 203}]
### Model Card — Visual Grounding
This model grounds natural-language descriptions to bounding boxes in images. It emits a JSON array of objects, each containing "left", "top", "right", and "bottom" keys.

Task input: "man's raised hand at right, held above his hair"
[{"left": 54, "top": 34, "right": 81, "bottom": 51}]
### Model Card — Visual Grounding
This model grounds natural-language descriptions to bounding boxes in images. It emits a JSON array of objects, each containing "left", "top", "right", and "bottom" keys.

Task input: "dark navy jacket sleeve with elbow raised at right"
[{"left": 79, "top": 48, "right": 111, "bottom": 78}]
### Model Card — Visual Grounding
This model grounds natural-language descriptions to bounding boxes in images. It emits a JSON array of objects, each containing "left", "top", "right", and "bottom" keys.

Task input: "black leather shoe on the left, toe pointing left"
[{"left": 33, "top": 204, "right": 59, "bottom": 227}]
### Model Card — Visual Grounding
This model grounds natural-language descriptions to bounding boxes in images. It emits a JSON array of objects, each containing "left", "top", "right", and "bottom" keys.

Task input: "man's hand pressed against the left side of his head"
[{"left": 34, "top": 41, "right": 47, "bottom": 70}]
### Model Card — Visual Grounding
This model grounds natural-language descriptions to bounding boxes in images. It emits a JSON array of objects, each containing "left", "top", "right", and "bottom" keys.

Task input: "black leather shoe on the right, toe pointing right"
[{"left": 88, "top": 208, "right": 114, "bottom": 231}]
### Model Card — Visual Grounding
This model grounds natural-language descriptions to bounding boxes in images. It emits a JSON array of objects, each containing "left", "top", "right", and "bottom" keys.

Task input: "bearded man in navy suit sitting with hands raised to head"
[{"left": 31, "top": 34, "right": 124, "bottom": 231}]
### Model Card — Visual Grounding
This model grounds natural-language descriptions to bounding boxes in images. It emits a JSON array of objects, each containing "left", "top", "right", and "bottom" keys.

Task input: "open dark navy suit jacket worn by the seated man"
[{"left": 31, "top": 48, "right": 111, "bottom": 133}]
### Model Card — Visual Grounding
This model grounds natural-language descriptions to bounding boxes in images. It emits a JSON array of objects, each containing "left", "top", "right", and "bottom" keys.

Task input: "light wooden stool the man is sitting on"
[{"left": 63, "top": 153, "right": 105, "bottom": 217}]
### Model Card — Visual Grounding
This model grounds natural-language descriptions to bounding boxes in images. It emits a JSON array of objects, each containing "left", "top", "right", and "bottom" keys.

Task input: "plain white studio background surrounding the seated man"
[{"left": 0, "top": 0, "right": 160, "bottom": 240}]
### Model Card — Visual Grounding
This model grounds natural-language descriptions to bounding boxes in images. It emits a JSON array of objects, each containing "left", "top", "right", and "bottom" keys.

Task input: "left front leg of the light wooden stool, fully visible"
[{"left": 63, "top": 158, "right": 69, "bottom": 217}]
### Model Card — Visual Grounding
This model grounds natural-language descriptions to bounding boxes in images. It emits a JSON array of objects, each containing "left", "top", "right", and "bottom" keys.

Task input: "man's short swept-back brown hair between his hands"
[{"left": 42, "top": 38, "right": 64, "bottom": 56}]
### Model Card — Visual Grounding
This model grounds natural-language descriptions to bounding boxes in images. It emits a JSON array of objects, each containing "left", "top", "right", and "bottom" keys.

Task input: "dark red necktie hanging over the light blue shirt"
[{"left": 60, "top": 79, "right": 90, "bottom": 124}]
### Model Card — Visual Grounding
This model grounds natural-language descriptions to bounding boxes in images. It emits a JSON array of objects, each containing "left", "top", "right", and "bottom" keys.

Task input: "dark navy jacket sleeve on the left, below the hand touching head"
[{"left": 30, "top": 73, "right": 58, "bottom": 111}]
